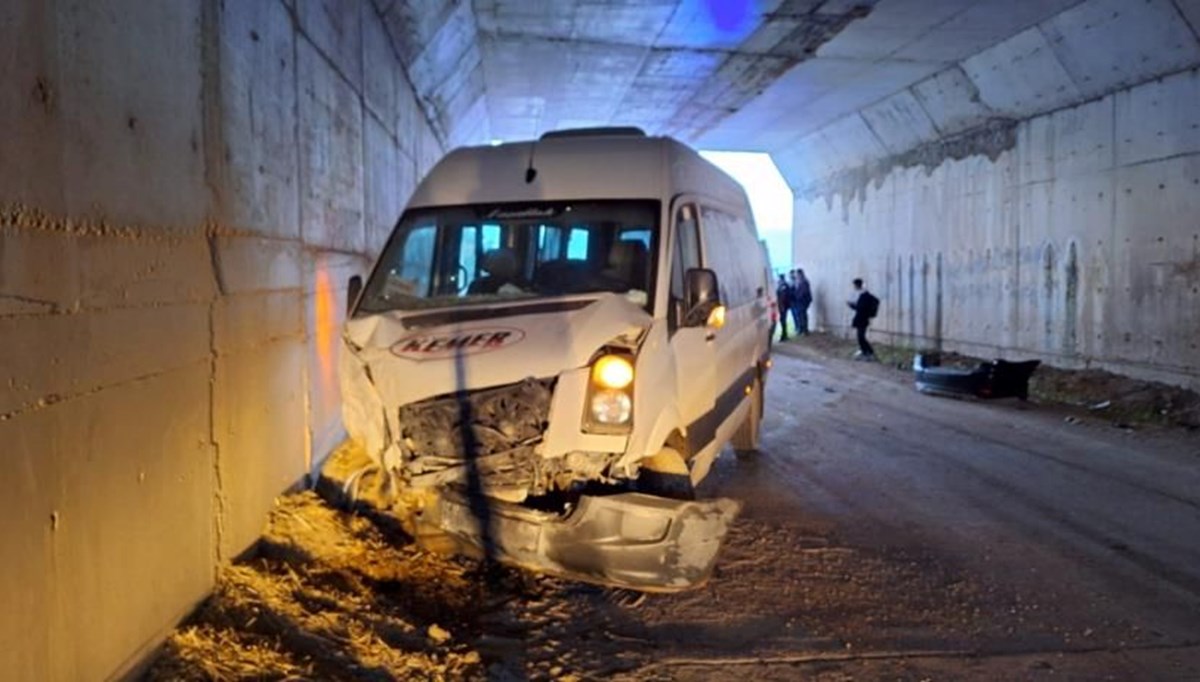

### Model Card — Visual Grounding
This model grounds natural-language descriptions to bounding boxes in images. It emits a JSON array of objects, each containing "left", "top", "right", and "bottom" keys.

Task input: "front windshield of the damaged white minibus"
[{"left": 358, "top": 201, "right": 660, "bottom": 312}]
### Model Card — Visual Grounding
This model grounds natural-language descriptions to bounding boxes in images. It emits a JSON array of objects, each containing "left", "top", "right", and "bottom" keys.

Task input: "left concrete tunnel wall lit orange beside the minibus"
[{"left": 0, "top": 0, "right": 443, "bottom": 680}]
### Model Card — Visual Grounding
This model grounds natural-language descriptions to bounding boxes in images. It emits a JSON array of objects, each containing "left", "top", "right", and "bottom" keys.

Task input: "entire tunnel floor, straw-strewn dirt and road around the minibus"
[{"left": 150, "top": 345, "right": 1200, "bottom": 682}]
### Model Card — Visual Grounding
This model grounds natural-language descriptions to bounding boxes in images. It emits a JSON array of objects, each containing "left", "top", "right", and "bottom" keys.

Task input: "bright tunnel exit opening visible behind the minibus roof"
[{"left": 700, "top": 150, "right": 794, "bottom": 273}]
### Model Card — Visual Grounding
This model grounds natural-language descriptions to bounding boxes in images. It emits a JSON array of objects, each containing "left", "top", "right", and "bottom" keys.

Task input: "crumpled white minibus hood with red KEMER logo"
[{"left": 343, "top": 294, "right": 652, "bottom": 407}]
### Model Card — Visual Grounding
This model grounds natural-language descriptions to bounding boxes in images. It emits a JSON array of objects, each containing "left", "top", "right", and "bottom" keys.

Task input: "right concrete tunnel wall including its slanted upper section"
[{"left": 776, "top": 0, "right": 1200, "bottom": 388}]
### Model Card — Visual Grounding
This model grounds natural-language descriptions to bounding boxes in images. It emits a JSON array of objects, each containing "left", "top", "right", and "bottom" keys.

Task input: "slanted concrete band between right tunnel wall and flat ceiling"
[{"left": 770, "top": 0, "right": 1200, "bottom": 191}]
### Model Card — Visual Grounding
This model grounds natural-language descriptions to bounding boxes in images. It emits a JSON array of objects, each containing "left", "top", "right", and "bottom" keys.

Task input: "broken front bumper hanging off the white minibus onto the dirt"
[{"left": 431, "top": 491, "right": 740, "bottom": 592}]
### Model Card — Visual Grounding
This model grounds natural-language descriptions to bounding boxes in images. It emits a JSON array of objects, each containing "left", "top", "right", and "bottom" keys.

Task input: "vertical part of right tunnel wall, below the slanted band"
[{"left": 794, "top": 70, "right": 1200, "bottom": 389}]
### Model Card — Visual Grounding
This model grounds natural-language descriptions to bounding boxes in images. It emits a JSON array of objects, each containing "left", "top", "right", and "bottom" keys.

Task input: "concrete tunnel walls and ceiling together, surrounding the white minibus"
[{"left": 0, "top": 0, "right": 1200, "bottom": 680}]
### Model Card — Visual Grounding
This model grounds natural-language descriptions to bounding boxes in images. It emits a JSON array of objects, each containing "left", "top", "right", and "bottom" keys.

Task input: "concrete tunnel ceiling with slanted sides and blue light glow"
[{"left": 376, "top": 0, "right": 1200, "bottom": 186}]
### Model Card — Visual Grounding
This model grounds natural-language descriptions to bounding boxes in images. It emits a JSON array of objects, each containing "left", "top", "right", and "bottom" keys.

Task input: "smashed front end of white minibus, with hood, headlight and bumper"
[{"left": 341, "top": 293, "right": 738, "bottom": 591}]
